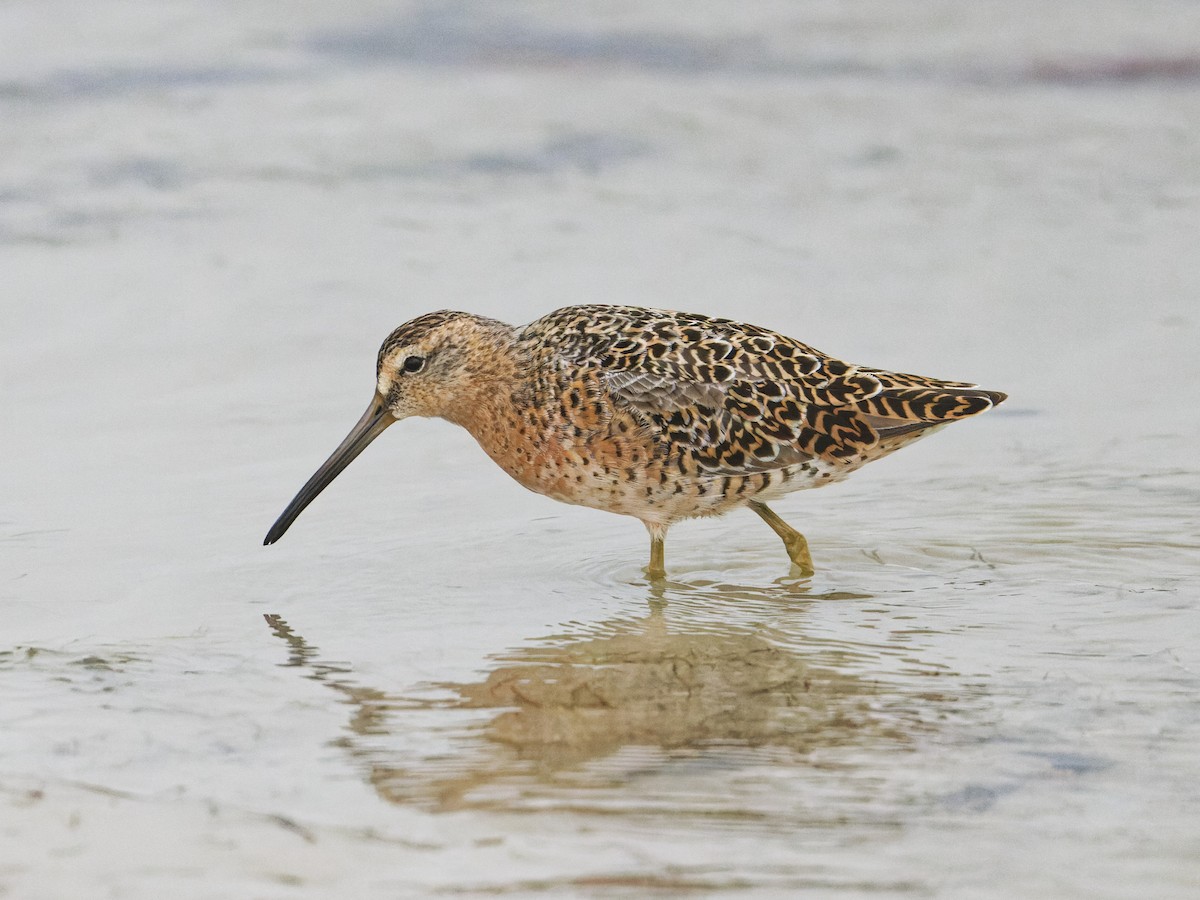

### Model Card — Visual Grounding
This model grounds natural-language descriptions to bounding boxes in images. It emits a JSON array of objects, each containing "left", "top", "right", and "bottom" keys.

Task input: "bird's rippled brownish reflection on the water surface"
[{"left": 266, "top": 584, "right": 936, "bottom": 810}]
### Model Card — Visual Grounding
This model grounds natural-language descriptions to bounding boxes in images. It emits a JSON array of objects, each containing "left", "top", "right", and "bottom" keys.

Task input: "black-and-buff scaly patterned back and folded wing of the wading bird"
[{"left": 518, "top": 306, "right": 1006, "bottom": 474}]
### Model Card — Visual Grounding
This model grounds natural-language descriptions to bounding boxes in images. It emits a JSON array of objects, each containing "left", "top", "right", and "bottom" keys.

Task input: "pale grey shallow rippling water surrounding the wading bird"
[{"left": 0, "top": 0, "right": 1200, "bottom": 898}]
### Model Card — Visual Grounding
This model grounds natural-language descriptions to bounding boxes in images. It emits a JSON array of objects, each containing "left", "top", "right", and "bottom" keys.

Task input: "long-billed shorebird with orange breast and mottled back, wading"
[{"left": 263, "top": 306, "right": 1006, "bottom": 577}]
